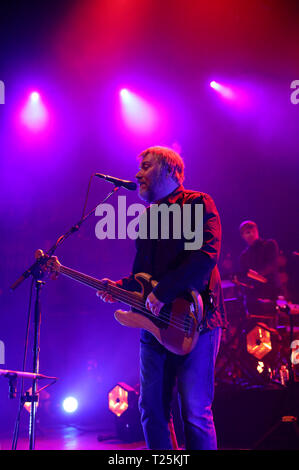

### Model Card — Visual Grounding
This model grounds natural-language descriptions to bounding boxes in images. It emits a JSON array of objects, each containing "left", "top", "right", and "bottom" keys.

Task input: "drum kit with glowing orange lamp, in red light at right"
[{"left": 216, "top": 270, "right": 299, "bottom": 387}]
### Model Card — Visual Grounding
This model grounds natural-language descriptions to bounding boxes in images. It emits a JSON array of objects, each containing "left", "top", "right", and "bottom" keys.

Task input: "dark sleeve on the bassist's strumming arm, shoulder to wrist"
[{"left": 153, "top": 194, "right": 221, "bottom": 303}]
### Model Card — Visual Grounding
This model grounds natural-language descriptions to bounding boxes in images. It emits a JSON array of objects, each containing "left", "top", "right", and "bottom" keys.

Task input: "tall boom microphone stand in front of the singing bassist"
[{"left": 10, "top": 184, "right": 121, "bottom": 450}]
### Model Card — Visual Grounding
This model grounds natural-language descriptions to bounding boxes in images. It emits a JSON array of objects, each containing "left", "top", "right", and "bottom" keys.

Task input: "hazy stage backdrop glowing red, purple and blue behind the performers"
[{"left": 0, "top": 0, "right": 299, "bottom": 440}]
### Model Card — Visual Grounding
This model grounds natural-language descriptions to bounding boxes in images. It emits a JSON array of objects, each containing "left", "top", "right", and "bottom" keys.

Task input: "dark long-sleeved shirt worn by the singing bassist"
[{"left": 118, "top": 185, "right": 227, "bottom": 328}]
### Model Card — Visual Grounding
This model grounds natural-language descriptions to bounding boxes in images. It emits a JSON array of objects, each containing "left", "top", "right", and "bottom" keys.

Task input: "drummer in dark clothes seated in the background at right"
[{"left": 239, "top": 220, "right": 281, "bottom": 313}]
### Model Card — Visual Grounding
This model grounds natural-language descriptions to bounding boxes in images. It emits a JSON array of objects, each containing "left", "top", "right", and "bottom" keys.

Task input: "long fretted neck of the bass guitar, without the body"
[{"left": 59, "top": 265, "right": 140, "bottom": 306}]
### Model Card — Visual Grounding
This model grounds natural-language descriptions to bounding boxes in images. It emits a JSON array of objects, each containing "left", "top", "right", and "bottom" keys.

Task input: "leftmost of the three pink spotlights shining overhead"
[{"left": 20, "top": 91, "right": 49, "bottom": 131}]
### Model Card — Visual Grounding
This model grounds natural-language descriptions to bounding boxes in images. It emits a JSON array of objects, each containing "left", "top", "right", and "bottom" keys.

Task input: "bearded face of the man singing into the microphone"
[{"left": 136, "top": 153, "right": 167, "bottom": 202}]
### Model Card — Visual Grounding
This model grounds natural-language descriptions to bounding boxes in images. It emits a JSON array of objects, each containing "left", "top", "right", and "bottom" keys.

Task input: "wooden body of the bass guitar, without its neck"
[{"left": 114, "top": 273, "right": 203, "bottom": 355}]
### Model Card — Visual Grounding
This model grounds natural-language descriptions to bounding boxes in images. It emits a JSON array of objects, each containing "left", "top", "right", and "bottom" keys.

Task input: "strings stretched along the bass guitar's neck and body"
[{"left": 60, "top": 266, "right": 195, "bottom": 333}]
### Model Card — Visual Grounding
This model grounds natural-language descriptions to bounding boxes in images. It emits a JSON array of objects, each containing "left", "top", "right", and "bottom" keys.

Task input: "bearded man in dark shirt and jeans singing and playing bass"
[{"left": 98, "top": 147, "right": 227, "bottom": 450}]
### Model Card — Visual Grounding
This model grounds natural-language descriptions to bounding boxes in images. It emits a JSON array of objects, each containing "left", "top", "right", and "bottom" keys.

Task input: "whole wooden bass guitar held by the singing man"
[{"left": 47, "top": 256, "right": 204, "bottom": 355}]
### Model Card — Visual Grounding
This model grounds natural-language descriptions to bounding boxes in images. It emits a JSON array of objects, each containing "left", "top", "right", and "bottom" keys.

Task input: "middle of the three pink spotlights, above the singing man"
[{"left": 120, "top": 88, "right": 158, "bottom": 133}]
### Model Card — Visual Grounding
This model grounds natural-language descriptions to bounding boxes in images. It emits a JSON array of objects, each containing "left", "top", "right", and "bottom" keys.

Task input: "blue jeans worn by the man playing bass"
[{"left": 139, "top": 328, "right": 221, "bottom": 450}]
